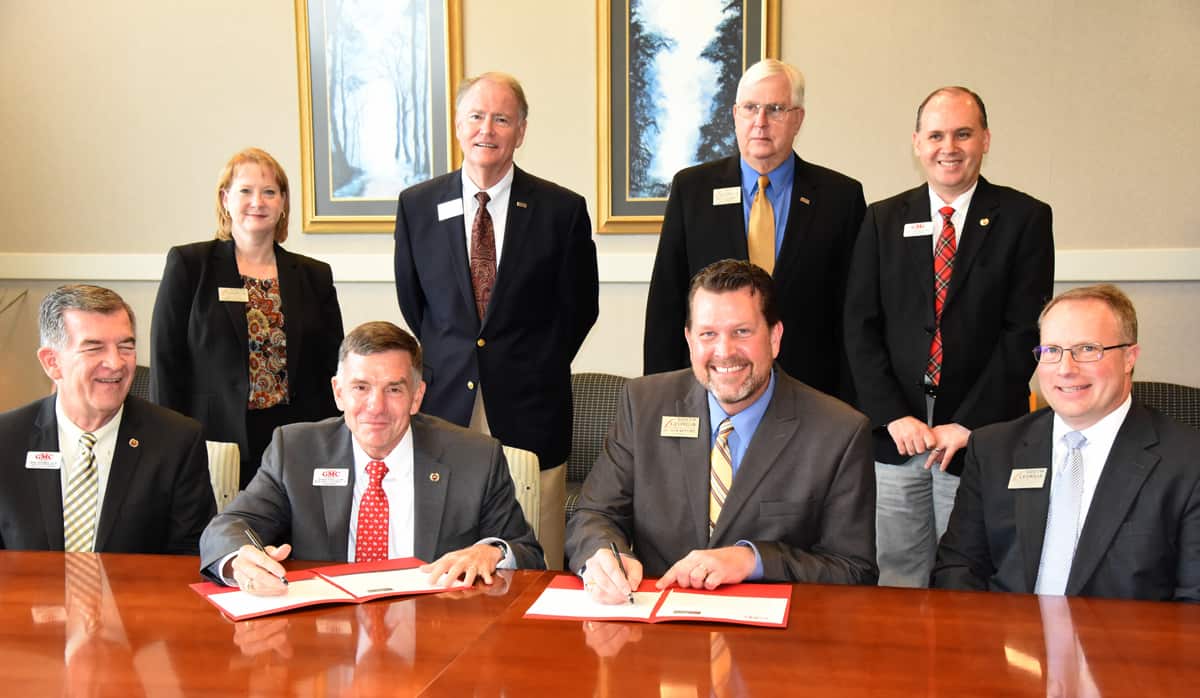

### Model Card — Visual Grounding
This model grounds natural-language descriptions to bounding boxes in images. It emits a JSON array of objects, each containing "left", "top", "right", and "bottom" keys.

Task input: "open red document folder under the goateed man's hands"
[{"left": 524, "top": 574, "right": 792, "bottom": 627}]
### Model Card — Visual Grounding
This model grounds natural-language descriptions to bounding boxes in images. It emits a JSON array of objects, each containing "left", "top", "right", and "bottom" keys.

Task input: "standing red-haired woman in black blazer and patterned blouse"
[{"left": 150, "top": 148, "right": 342, "bottom": 488}]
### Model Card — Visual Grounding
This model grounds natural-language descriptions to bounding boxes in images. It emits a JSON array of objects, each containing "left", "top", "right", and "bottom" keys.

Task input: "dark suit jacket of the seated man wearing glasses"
[{"left": 932, "top": 403, "right": 1200, "bottom": 601}]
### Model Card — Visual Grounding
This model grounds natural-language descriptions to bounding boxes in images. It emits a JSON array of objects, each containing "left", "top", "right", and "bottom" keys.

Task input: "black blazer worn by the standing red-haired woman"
[{"left": 150, "top": 240, "right": 342, "bottom": 458}]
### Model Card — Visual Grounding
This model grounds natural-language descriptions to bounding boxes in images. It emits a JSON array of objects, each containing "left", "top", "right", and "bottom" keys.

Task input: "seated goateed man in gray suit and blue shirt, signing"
[{"left": 566, "top": 259, "right": 878, "bottom": 603}]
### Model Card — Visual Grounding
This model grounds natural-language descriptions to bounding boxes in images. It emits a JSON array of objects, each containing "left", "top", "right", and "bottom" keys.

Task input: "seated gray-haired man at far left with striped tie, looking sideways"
[{"left": 0, "top": 284, "right": 216, "bottom": 555}]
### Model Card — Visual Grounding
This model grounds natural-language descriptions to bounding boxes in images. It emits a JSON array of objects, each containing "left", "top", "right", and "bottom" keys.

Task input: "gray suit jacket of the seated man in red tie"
[{"left": 200, "top": 414, "right": 545, "bottom": 580}]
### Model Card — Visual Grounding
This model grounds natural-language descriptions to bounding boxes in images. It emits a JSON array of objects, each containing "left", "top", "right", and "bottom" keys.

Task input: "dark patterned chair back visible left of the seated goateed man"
[{"left": 566, "top": 373, "right": 629, "bottom": 519}]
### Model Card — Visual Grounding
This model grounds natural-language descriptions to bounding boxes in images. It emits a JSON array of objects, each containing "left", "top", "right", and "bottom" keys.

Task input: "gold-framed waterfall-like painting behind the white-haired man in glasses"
[{"left": 596, "top": 0, "right": 779, "bottom": 233}]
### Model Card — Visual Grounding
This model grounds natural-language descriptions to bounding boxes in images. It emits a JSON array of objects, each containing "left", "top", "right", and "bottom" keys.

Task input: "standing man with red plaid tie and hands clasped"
[{"left": 845, "top": 88, "right": 1054, "bottom": 586}]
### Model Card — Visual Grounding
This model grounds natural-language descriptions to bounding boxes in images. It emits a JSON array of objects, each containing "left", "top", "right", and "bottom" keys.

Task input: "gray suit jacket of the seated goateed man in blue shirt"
[{"left": 566, "top": 366, "right": 878, "bottom": 584}]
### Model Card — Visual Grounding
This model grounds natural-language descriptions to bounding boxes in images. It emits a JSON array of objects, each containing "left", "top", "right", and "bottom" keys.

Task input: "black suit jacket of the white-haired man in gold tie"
[{"left": 642, "top": 155, "right": 866, "bottom": 397}]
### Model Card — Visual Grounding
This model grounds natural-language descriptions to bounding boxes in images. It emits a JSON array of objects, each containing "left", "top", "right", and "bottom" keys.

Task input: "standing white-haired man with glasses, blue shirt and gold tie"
[{"left": 643, "top": 59, "right": 865, "bottom": 398}]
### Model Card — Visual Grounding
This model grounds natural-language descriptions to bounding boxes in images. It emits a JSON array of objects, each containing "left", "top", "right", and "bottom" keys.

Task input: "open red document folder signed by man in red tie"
[{"left": 191, "top": 558, "right": 469, "bottom": 620}]
